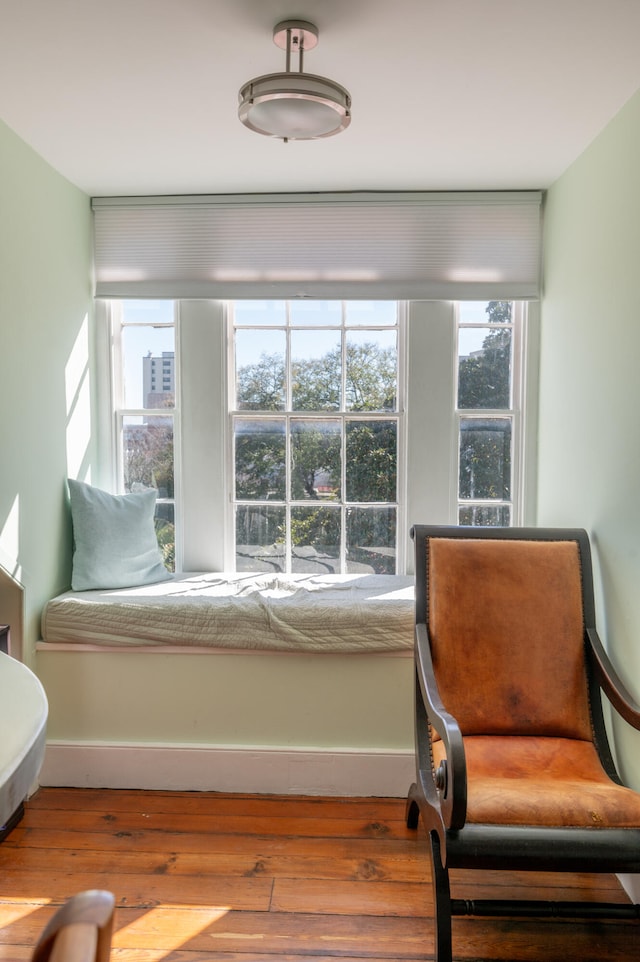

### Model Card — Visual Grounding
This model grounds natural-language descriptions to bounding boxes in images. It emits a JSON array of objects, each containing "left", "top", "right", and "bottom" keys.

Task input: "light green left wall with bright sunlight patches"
[{"left": 0, "top": 123, "right": 93, "bottom": 662}]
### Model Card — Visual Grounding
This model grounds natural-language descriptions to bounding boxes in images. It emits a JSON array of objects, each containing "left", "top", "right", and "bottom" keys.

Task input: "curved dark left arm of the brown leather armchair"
[{"left": 416, "top": 623, "right": 467, "bottom": 830}]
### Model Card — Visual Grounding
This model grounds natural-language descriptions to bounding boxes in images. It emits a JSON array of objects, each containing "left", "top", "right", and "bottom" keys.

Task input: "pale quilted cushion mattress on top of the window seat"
[{"left": 39, "top": 572, "right": 414, "bottom": 653}]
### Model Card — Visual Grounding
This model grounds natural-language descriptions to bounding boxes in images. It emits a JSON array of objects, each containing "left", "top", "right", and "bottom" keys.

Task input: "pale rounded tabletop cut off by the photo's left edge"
[{"left": 0, "top": 652, "right": 48, "bottom": 840}]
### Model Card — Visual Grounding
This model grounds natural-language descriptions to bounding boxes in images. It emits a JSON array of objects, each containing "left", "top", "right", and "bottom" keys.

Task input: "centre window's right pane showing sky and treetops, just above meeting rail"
[{"left": 346, "top": 331, "right": 398, "bottom": 411}]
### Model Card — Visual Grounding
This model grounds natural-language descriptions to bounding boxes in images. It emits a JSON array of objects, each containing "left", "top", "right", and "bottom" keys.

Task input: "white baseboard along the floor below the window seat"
[{"left": 39, "top": 741, "right": 415, "bottom": 797}]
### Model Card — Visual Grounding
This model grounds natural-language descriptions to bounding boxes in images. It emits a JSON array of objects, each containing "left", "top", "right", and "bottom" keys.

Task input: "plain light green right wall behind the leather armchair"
[{"left": 538, "top": 93, "right": 640, "bottom": 789}]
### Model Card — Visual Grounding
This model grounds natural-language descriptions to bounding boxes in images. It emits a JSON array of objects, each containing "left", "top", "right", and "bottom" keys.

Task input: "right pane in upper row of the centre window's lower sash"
[{"left": 346, "top": 421, "right": 398, "bottom": 501}]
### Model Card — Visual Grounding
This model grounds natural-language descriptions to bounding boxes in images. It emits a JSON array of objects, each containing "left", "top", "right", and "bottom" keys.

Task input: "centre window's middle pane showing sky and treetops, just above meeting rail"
[{"left": 291, "top": 331, "right": 342, "bottom": 411}]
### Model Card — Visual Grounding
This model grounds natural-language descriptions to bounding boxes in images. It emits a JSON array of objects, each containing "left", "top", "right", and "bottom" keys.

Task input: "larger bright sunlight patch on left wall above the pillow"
[{"left": 65, "top": 314, "right": 91, "bottom": 481}]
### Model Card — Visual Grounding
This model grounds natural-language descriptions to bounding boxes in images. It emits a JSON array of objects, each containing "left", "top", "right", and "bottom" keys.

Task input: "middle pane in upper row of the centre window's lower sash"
[{"left": 291, "top": 420, "right": 340, "bottom": 501}]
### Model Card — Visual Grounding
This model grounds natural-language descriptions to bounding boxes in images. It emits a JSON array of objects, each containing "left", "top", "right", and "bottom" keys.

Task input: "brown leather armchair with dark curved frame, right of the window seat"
[{"left": 407, "top": 525, "right": 640, "bottom": 962}]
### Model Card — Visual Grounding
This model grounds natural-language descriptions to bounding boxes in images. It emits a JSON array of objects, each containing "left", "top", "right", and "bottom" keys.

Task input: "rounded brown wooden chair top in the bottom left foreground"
[{"left": 31, "top": 889, "right": 115, "bottom": 962}]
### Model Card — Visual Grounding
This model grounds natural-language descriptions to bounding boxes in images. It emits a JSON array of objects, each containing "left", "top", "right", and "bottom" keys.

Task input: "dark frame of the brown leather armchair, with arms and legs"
[{"left": 406, "top": 525, "right": 640, "bottom": 962}]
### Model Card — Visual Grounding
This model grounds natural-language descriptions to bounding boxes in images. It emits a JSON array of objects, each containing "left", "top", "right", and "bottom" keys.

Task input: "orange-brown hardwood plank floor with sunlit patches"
[{"left": 0, "top": 788, "right": 640, "bottom": 962}]
